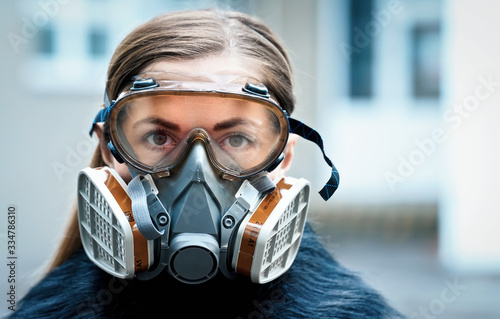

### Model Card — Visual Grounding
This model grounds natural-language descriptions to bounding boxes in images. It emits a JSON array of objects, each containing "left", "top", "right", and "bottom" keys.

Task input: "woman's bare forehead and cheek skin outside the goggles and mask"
[{"left": 95, "top": 55, "right": 297, "bottom": 183}]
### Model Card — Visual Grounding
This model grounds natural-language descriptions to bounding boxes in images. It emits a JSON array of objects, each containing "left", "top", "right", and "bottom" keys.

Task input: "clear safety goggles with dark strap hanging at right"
[{"left": 91, "top": 72, "right": 338, "bottom": 199}]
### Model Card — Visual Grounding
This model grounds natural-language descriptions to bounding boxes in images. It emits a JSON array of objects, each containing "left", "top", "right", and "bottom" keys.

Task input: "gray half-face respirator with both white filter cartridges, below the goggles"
[{"left": 78, "top": 139, "right": 309, "bottom": 284}]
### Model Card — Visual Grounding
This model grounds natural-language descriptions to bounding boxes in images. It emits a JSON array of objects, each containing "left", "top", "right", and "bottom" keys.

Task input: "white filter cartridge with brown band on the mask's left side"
[{"left": 77, "top": 167, "right": 154, "bottom": 279}]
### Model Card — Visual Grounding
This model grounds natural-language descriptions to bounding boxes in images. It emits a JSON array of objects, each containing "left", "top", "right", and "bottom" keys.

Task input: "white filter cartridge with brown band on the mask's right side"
[{"left": 232, "top": 177, "right": 310, "bottom": 284}]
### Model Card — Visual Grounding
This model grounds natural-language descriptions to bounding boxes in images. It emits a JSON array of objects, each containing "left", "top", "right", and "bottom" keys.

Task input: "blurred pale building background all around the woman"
[{"left": 0, "top": 0, "right": 500, "bottom": 318}]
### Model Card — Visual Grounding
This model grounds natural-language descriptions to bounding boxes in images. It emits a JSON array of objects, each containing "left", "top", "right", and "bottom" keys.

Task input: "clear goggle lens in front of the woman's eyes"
[{"left": 110, "top": 91, "right": 288, "bottom": 177}]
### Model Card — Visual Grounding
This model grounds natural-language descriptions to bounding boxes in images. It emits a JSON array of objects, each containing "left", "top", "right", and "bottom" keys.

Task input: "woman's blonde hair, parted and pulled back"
[{"left": 49, "top": 9, "right": 295, "bottom": 270}]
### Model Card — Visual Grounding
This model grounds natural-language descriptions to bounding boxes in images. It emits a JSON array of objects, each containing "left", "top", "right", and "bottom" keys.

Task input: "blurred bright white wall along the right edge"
[{"left": 440, "top": 0, "right": 500, "bottom": 273}]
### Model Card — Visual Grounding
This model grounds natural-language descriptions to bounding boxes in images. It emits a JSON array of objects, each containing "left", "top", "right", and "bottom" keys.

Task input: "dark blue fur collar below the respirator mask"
[{"left": 12, "top": 226, "right": 401, "bottom": 319}]
